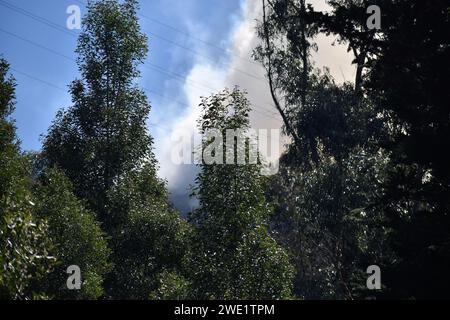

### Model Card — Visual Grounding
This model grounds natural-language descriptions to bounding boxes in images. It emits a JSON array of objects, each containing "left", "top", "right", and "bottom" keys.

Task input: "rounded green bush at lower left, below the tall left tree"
[{"left": 35, "top": 169, "right": 111, "bottom": 299}]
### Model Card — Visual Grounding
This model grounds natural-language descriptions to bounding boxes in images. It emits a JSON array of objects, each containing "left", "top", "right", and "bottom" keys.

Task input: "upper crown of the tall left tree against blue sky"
[{"left": 43, "top": 0, "right": 154, "bottom": 222}]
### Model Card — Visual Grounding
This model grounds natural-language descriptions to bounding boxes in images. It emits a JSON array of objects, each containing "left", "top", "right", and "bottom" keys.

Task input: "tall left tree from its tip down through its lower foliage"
[{"left": 43, "top": 0, "right": 188, "bottom": 299}]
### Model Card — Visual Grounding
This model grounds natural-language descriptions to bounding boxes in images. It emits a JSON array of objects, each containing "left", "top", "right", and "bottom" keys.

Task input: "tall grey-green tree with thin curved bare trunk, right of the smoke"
[{"left": 255, "top": 0, "right": 387, "bottom": 299}]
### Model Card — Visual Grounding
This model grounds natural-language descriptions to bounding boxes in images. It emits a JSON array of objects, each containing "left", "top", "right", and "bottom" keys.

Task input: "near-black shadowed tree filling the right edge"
[{"left": 365, "top": 0, "right": 450, "bottom": 298}]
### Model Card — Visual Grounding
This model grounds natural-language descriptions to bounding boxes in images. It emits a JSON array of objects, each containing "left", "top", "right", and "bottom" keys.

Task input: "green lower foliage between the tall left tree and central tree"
[{"left": 109, "top": 165, "right": 190, "bottom": 299}]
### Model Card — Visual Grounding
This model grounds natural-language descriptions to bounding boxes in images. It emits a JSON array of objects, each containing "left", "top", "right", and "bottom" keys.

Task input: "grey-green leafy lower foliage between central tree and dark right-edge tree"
[{"left": 270, "top": 148, "right": 392, "bottom": 299}]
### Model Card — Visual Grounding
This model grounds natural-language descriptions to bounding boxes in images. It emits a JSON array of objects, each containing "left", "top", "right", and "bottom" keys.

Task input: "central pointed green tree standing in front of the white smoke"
[{"left": 189, "top": 89, "right": 293, "bottom": 299}]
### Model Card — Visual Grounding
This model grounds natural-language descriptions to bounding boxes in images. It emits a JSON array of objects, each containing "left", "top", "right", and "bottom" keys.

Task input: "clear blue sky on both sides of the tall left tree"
[{"left": 0, "top": 0, "right": 241, "bottom": 150}]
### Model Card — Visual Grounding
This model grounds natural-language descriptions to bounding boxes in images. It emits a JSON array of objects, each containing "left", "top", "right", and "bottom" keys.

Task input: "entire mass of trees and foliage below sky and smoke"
[{"left": 0, "top": 0, "right": 450, "bottom": 299}]
